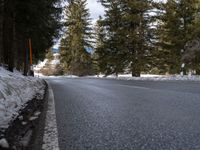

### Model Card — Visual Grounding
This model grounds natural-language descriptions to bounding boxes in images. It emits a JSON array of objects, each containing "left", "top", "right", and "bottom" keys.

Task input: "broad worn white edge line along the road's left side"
[{"left": 42, "top": 84, "right": 59, "bottom": 150}]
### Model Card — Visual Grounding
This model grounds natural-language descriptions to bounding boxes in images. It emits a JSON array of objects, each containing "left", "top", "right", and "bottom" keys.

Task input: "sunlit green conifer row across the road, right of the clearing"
[{"left": 60, "top": 0, "right": 200, "bottom": 76}]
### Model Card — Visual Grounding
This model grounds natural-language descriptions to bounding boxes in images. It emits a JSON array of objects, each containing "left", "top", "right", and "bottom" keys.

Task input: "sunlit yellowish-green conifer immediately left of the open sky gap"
[{"left": 61, "top": 0, "right": 92, "bottom": 76}]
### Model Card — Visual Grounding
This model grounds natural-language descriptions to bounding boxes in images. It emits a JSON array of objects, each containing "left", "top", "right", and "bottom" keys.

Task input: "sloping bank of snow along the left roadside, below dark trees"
[{"left": 0, "top": 67, "right": 45, "bottom": 128}]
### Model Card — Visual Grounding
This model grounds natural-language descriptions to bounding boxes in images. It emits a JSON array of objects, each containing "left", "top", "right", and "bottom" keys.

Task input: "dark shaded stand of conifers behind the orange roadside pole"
[{"left": 0, "top": 0, "right": 62, "bottom": 75}]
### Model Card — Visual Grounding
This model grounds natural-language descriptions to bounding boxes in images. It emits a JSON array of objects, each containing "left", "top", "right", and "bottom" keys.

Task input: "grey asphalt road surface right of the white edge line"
[{"left": 49, "top": 78, "right": 200, "bottom": 150}]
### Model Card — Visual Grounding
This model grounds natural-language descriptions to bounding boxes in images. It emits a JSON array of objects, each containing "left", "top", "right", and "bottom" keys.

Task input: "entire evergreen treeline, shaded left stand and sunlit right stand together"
[{"left": 0, "top": 0, "right": 200, "bottom": 76}]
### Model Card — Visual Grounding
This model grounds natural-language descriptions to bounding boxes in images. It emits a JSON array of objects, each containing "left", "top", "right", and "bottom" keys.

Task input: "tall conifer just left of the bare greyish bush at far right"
[{"left": 160, "top": 0, "right": 198, "bottom": 74}]
